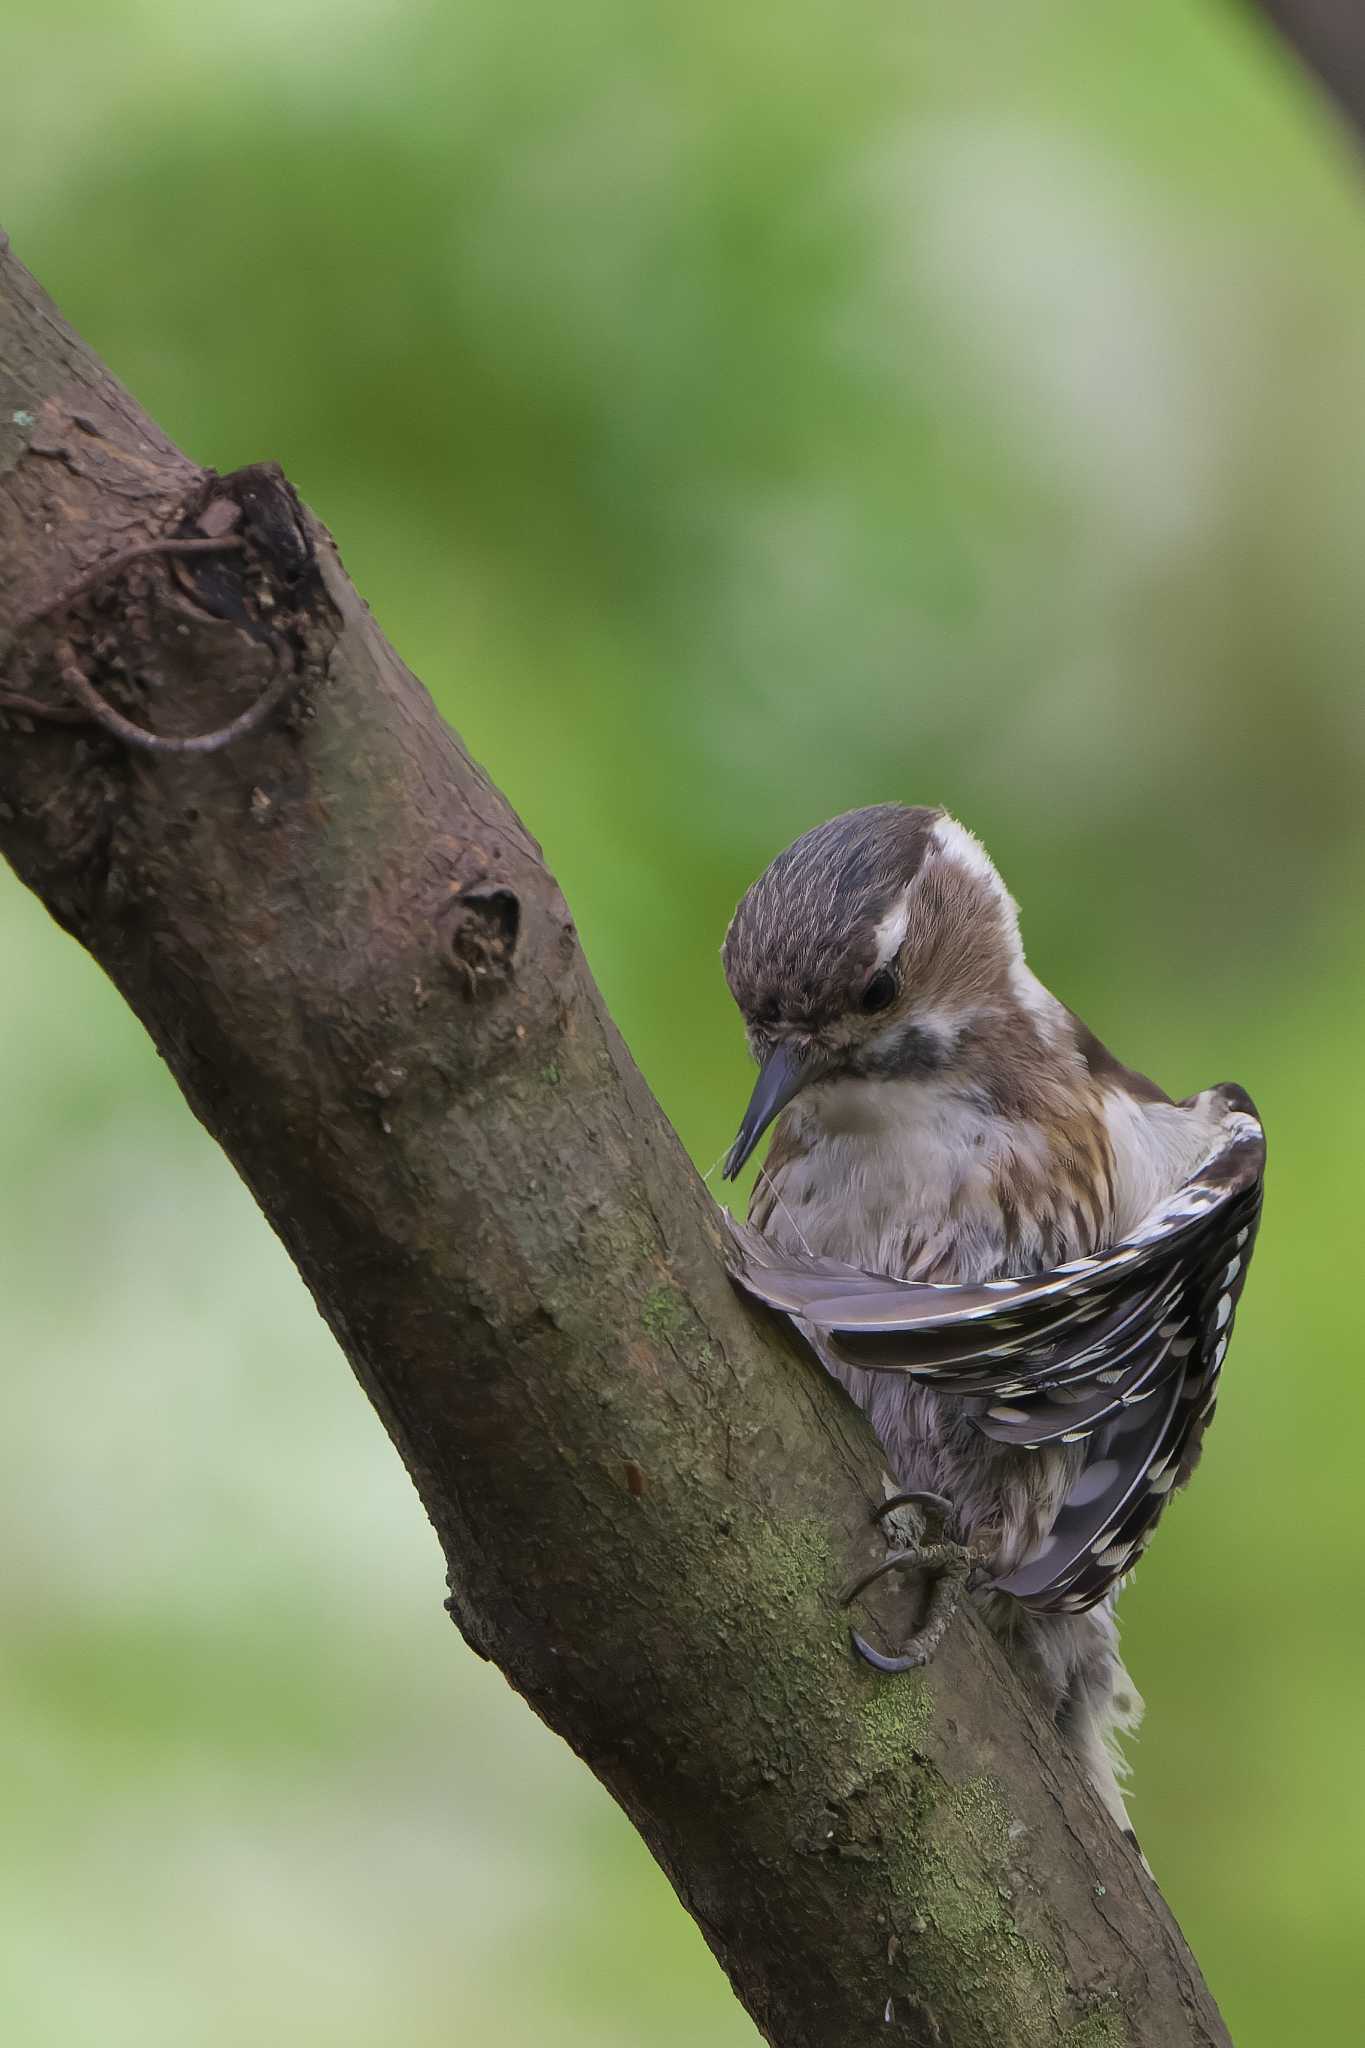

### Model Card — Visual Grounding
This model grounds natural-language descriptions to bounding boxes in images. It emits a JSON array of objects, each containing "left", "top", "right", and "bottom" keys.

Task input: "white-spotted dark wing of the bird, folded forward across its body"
[{"left": 731, "top": 1085, "right": 1265, "bottom": 1612}]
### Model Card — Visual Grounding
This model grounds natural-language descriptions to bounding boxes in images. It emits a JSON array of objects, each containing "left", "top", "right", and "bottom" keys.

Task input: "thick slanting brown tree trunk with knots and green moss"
[{"left": 0, "top": 238, "right": 1226, "bottom": 2048}]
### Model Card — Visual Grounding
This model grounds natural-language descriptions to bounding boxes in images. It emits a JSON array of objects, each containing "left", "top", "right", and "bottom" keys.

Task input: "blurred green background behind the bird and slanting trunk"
[{"left": 0, "top": 0, "right": 1365, "bottom": 2048}]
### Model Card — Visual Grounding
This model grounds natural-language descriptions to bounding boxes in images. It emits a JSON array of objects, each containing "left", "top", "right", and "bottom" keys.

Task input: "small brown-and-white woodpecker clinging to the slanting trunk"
[{"left": 722, "top": 803, "right": 1265, "bottom": 1843}]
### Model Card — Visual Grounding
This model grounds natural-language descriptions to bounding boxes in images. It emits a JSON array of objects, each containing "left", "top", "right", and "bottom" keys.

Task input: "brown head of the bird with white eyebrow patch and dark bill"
[{"left": 724, "top": 803, "right": 1042, "bottom": 1180}]
